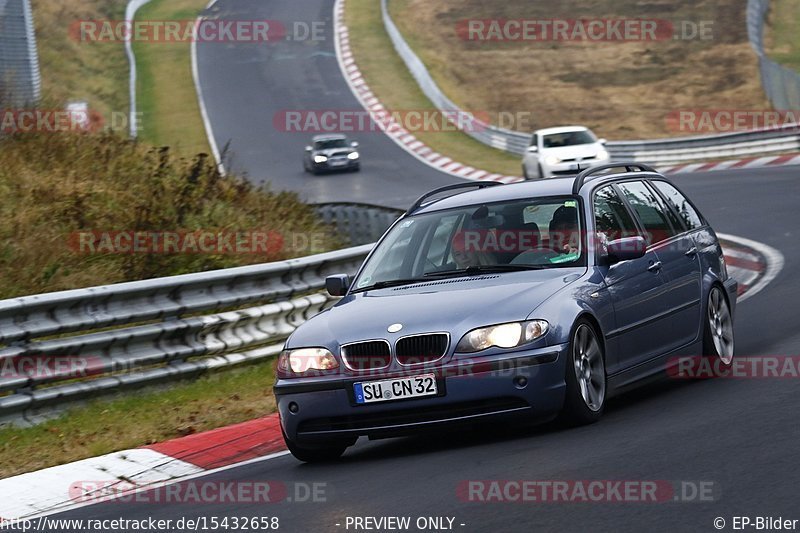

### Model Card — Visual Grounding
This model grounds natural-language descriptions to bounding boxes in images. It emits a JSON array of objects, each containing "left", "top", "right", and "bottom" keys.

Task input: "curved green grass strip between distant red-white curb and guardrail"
[{"left": 345, "top": 0, "right": 520, "bottom": 176}]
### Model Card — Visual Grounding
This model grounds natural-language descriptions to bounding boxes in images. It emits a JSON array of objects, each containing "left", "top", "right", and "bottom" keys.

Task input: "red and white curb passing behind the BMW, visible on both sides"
[{"left": 0, "top": 239, "right": 784, "bottom": 524}]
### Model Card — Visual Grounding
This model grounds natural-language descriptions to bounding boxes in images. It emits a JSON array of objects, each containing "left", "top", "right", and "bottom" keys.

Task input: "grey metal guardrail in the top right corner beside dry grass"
[{"left": 747, "top": 0, "right": 800, "bottom": 110}]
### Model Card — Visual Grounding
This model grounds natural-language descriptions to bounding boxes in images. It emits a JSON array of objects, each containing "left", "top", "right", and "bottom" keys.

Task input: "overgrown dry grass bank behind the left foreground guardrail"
[{"left": 0, "top": 133, "right": 340, "bottom": 298}]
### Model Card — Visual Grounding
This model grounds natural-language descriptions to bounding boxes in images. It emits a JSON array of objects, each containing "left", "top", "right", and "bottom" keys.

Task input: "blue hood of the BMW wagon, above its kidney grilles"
[{"left": 287, "top": 268, "right": 586, "bottom": 350}]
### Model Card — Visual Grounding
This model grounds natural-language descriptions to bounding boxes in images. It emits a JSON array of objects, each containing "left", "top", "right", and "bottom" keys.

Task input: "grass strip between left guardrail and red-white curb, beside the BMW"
[{"left": 0, "top": 361, "right": 275, "bottom": 478}]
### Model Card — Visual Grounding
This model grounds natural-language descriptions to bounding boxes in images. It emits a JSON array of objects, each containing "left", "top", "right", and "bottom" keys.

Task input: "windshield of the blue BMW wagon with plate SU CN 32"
[{"left": 353, "top": 197, "right": 586, "bottom": 290}]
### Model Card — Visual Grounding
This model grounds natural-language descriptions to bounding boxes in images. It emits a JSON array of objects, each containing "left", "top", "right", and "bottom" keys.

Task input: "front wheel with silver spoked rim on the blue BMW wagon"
[{"left": 561, "top": 319, "right": 606, "bottom": 426}]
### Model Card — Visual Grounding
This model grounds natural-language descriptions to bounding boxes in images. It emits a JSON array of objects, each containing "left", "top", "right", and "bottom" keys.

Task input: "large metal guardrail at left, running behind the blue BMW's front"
[{"left": 0, "top": 244, "right": 372, "bottom": 423}]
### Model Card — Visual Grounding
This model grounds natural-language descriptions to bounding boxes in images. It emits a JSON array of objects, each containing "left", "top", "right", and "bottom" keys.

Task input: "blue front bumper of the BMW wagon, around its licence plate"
[{"left": 275, "top": 344, "right": 568, "bottom": 444}]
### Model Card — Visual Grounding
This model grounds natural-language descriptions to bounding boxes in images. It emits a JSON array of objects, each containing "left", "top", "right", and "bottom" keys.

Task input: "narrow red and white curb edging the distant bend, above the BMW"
[{"left": 333, "top": 0, "right": 522, "bottom": 183}]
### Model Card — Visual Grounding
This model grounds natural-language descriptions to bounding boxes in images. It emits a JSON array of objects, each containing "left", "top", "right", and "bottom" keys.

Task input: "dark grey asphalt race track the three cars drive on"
[{"left": 48, "top": 0, "right": 800, "bottom": 532}]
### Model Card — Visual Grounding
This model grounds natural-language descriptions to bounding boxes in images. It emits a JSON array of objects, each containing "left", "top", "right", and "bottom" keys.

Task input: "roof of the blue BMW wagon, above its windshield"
[{"left": 412, "top": 171, "right": 669, "bottom": 215}]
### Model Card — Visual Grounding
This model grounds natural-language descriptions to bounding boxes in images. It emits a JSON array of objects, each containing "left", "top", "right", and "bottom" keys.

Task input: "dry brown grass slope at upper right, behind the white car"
[{"left": 390, "top": 0, "right": 769, "bottom": 139}]
